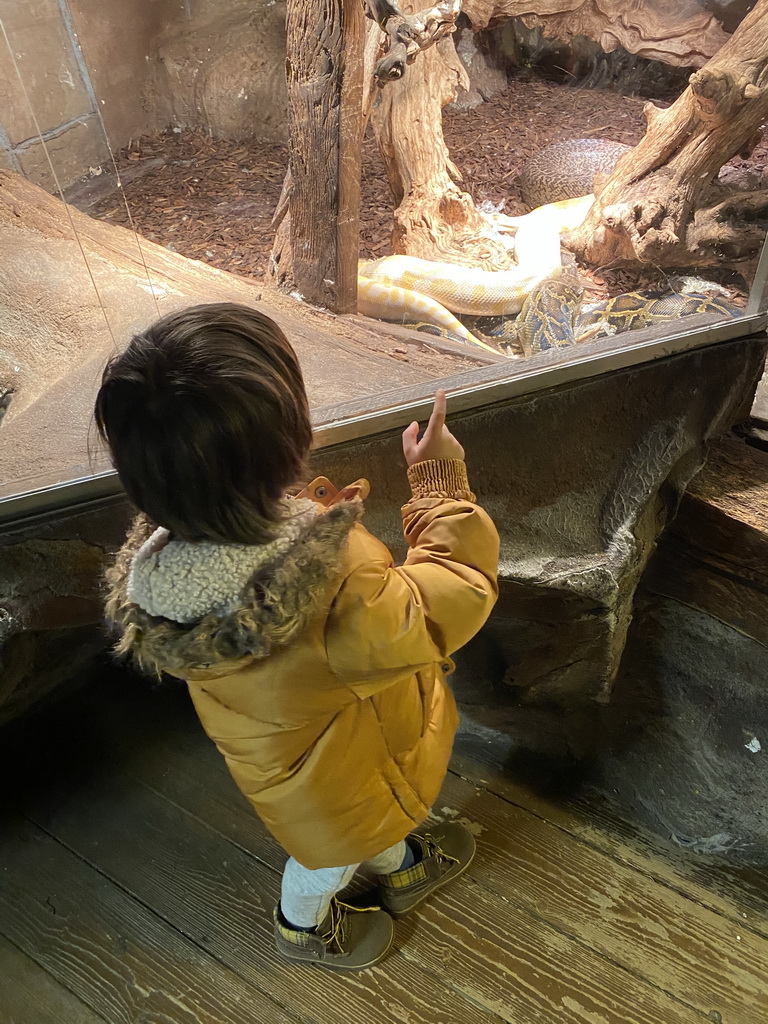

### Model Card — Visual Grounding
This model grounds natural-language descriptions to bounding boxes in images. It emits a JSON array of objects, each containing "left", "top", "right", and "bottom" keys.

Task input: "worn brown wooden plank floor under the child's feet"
[{"left": 0, "top": 676, "right": 768, "bottom": 1024}]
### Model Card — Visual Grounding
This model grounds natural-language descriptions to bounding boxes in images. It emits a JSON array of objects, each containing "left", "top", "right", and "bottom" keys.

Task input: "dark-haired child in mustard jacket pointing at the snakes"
[{"left": 95, "top": 304, "right": 499, "bottom": 970}]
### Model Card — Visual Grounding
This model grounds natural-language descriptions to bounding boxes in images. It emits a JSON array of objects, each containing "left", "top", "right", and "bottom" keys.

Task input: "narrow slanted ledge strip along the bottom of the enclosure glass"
[{"left": 0, "top": 309, "right": 768, "bottom": 532}]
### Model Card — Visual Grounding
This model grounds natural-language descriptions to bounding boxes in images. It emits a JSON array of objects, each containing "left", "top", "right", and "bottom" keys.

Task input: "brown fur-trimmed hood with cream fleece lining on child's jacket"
[{"left": 106, "top": 501, "right": 362, "bottom": 680}]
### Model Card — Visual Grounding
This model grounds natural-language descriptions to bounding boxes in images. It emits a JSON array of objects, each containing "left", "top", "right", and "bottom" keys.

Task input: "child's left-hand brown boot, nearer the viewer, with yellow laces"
[{"left": 274, "top": 899, "right": 394, "bottom": 971}]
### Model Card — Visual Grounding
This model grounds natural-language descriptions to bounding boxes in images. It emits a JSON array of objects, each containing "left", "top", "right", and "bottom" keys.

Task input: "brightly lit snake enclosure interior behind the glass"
[{"left": 0, "top": 0, "right": 768, "bottom": 494}]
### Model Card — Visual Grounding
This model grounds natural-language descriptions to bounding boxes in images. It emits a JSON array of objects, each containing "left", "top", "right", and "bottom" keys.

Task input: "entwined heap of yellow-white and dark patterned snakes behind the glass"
[{"left": 357, "top": 139, "right": 739, "bottom": 355}]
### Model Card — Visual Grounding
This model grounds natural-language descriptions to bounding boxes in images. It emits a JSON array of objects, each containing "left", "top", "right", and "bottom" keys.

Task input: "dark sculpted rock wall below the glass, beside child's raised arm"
[{"left": 333, "top": 339, "right": 765, "bottom": 704}]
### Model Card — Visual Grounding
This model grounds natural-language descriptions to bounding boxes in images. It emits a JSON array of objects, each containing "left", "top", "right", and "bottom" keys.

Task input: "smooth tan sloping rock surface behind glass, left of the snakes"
[{"left": 0, "top": 171, "right": 488, "bottom": 494}]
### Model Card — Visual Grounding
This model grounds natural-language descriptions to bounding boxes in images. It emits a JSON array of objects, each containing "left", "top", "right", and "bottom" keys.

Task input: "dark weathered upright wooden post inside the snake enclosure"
[{"left": 286, "top": 0, "right": 366, "bottom": 313}]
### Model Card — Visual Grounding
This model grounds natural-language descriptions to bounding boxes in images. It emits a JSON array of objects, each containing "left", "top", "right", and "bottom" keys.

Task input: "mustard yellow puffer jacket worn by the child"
[{"left": 108, "top": 461, "right": 499, "bottom": 868}]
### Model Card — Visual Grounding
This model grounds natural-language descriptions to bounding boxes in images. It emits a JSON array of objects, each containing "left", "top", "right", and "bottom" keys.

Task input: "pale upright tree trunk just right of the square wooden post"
[{"left": 373, "top": 5, "right": 518, "bottom": 270}]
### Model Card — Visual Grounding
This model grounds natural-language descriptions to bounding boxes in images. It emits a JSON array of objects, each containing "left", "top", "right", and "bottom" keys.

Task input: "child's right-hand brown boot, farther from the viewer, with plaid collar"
[{"left": 379, "top": 822, "right": 476, "bottom": 918}]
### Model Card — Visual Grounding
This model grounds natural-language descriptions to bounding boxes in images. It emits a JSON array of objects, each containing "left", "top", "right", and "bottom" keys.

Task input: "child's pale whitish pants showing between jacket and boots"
[{"left": 280, "top": 840, "right": 408, "bottom": 928}]
